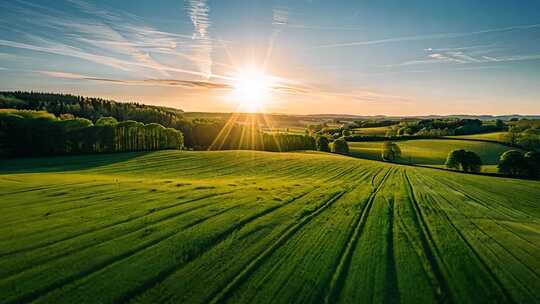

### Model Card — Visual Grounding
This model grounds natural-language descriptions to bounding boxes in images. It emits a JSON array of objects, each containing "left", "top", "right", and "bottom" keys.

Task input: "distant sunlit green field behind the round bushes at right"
[{"left": 349, "top": 139, "right": 512, "bottom": 172}]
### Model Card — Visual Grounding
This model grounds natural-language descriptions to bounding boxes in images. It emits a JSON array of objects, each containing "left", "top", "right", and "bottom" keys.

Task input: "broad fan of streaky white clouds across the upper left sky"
[{"left": 0, "top": 0, "right": 227, "bottom": 79}]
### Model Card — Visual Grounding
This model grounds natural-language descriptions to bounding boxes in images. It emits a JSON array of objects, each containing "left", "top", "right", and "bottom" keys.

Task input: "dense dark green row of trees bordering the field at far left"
[{"left": 0, "top": 110, "right": 184, "bottom": 156}]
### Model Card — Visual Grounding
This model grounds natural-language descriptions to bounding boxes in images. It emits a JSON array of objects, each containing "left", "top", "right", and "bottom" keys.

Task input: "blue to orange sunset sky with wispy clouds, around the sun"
[{"left": 0, "top": 0, "right": 540, "bottom": 115}]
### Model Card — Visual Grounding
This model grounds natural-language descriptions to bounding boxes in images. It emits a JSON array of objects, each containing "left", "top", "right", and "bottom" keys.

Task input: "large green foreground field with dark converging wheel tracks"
[{"left": 0, "top": 151, "right": 540, "bottom": 303}]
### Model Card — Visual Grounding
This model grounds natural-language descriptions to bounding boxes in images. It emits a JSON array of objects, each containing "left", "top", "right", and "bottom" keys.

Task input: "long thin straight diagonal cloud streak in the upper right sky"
[{"left": 312, "top": 24, "right": 540, "bottom": 49}]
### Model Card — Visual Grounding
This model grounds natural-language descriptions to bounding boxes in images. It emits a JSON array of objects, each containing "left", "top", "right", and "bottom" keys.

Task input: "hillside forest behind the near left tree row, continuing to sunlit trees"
[{"left": 0, "top": 91, "right": 315, "bottom": 151}]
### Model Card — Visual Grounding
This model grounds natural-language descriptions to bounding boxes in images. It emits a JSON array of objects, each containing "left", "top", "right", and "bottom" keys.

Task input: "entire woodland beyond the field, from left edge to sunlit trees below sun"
[{"left": 0, "top": 92, "right": 315, "bottom": 156}]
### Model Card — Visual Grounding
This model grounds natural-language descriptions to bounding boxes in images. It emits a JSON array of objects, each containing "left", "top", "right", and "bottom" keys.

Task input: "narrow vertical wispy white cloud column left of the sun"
[{"left": 187, "top": 0, "right": 212, "bottom": 79}]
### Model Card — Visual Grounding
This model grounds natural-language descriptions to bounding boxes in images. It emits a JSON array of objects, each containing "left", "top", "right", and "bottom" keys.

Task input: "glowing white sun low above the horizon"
[{"left": 232, "top": 68, "right": 273, "bottom": 113}]
